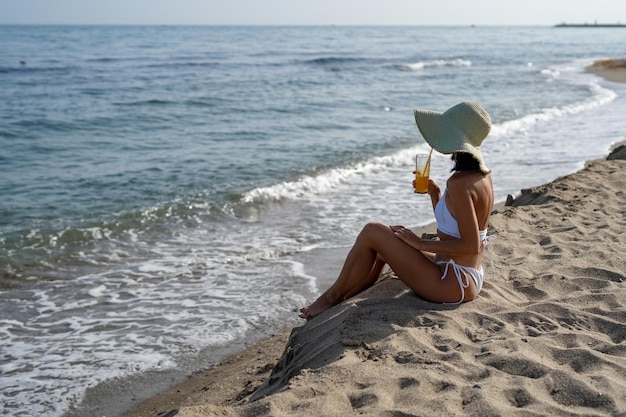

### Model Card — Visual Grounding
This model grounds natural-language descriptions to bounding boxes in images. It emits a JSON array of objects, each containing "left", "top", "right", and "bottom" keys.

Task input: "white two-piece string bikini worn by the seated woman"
[{"left": 435, "top": 190, "right": 489, "bottom": 304}]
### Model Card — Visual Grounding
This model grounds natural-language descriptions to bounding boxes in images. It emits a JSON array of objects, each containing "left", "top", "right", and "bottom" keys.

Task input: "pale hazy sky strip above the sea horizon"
[{"left": 0, "top": 0, "right": 626, "bottom": 26}]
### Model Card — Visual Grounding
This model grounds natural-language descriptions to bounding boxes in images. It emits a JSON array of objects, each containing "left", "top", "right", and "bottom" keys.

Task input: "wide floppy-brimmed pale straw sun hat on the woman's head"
[{"left": 413, "top": 101, "right": 491, "bottom": 174}]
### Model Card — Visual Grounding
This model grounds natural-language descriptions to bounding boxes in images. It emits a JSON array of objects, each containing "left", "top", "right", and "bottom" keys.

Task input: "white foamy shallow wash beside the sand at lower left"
[{"left": 0, "top": 223, "right": 315, "bottom": 417}]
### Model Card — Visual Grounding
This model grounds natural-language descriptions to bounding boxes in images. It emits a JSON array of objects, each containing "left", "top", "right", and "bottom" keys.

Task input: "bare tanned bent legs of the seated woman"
[{"left": 300, "top": 223, "right": 473, "bottom": 318}]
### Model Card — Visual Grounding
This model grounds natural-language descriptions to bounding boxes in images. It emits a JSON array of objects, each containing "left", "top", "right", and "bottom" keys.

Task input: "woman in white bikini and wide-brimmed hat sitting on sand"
[{"left": 300, "top": 102, "right": 494, "bottom": 319}]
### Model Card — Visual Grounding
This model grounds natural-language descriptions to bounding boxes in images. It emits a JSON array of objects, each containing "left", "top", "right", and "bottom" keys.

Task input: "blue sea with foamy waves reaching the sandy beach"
[{"left": 0, "top": 26, "right": 626, "bottom": 417}]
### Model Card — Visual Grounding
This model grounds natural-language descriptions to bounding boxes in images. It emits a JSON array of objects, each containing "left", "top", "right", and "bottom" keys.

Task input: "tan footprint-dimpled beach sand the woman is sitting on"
[{"left": 118, "top": 62, "right": 626, "bottom": 417}]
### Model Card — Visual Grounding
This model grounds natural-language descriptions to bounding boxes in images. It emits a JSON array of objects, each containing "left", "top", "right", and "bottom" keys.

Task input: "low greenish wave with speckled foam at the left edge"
[{"left": 0, "top": 200, "right": 225, "bottom": 280}]
